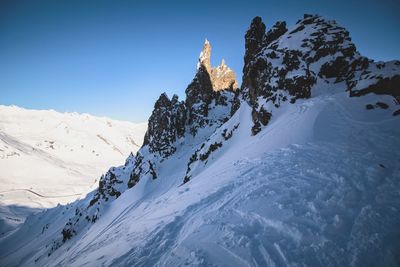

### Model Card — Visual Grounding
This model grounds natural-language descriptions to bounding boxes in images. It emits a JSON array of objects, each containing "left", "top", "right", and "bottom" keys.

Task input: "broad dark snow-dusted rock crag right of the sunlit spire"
[{"left": 241, "top": 15, "right": 398, "bottom": 135}]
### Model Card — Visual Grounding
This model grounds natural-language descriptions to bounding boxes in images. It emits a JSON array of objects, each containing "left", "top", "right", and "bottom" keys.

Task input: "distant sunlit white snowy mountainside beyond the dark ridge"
[{"left": 0, "top": 106, "right": 147, "bottom": 234}]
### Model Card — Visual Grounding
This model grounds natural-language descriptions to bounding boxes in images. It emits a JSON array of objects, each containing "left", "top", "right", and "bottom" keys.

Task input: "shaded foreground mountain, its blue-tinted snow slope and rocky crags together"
[{"left": 0, "top": 15, "right": 400, "bottom": 266}]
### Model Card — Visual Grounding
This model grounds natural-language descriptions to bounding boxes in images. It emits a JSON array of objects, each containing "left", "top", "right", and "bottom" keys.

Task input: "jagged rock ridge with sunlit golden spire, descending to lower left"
[{"left": 49, "top": 40, "right": 238, "bottom": 249}]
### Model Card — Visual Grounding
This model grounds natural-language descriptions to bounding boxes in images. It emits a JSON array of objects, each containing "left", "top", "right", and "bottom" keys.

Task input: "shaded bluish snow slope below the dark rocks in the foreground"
[{"left": 0, "top": 89, "right": 400, "bottom": 266}]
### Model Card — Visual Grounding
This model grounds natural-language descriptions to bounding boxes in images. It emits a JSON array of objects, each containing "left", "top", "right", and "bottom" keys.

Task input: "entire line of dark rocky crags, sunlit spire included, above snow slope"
[{"left": 23, "top": 15, "right": 400, "bottom": 258}]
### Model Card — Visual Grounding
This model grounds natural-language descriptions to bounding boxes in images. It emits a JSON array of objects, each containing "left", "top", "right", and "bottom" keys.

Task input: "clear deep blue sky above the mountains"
[{"left": 0, "top": 0, "right": 400, "bottom": 122}]
